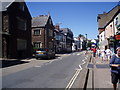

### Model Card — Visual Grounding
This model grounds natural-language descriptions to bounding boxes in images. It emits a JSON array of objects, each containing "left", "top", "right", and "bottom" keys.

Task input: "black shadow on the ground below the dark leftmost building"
[{"left": 2, "top": 60, "right": 29, "bottom": 68}]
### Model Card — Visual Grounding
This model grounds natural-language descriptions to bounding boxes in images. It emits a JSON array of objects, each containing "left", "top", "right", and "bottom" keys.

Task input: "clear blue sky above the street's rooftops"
[{"left": 26, "top": 2, "right": 118, "bottom": 39}]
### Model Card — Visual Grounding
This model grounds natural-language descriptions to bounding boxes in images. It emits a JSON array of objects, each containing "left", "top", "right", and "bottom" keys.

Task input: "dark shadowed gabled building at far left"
[{"left": 1, "top": 0, "right": 32, "bottom": 59}]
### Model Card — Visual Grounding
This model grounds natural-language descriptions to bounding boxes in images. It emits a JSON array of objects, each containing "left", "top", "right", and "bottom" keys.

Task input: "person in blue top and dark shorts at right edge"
[{"left": 110, "top": 47, "right": 120, "bottom": 90}]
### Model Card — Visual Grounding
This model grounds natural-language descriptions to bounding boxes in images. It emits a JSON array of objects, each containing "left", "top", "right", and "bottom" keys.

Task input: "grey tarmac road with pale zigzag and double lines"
[{"left": 2, "top": 52, "right": 89, "bottom": 88}]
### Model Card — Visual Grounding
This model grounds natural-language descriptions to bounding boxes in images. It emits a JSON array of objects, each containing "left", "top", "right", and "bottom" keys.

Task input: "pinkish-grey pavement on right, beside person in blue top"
[{"left": 86, "top": 57, "right": 120, "bottom": 90}]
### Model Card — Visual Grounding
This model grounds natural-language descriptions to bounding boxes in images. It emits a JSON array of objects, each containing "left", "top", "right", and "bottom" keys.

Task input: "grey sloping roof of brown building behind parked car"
[{"left": 32, "top": 15, "right": 49, "bottom": 27}]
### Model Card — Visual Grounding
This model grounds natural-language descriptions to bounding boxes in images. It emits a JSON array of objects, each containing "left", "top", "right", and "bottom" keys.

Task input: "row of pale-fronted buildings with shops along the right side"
[{"left": 97, "top": 5, "right": 120, "bottom": 52}]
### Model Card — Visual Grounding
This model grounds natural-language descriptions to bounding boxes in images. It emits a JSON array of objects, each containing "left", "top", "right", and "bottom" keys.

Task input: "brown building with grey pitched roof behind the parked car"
[{"left": 32, "top": 15, "right": 54, "bottom": 50}]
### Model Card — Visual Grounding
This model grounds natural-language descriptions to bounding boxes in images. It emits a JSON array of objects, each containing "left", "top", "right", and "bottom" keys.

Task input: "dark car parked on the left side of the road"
[{"left": 35, "top": 48, "right": 55, "bottom": 59}]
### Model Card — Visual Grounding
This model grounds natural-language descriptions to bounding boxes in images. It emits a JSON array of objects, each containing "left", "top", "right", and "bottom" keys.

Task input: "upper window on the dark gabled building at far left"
[{"left": 17, "top": 17, "right": 27, "bottom": 30}]
